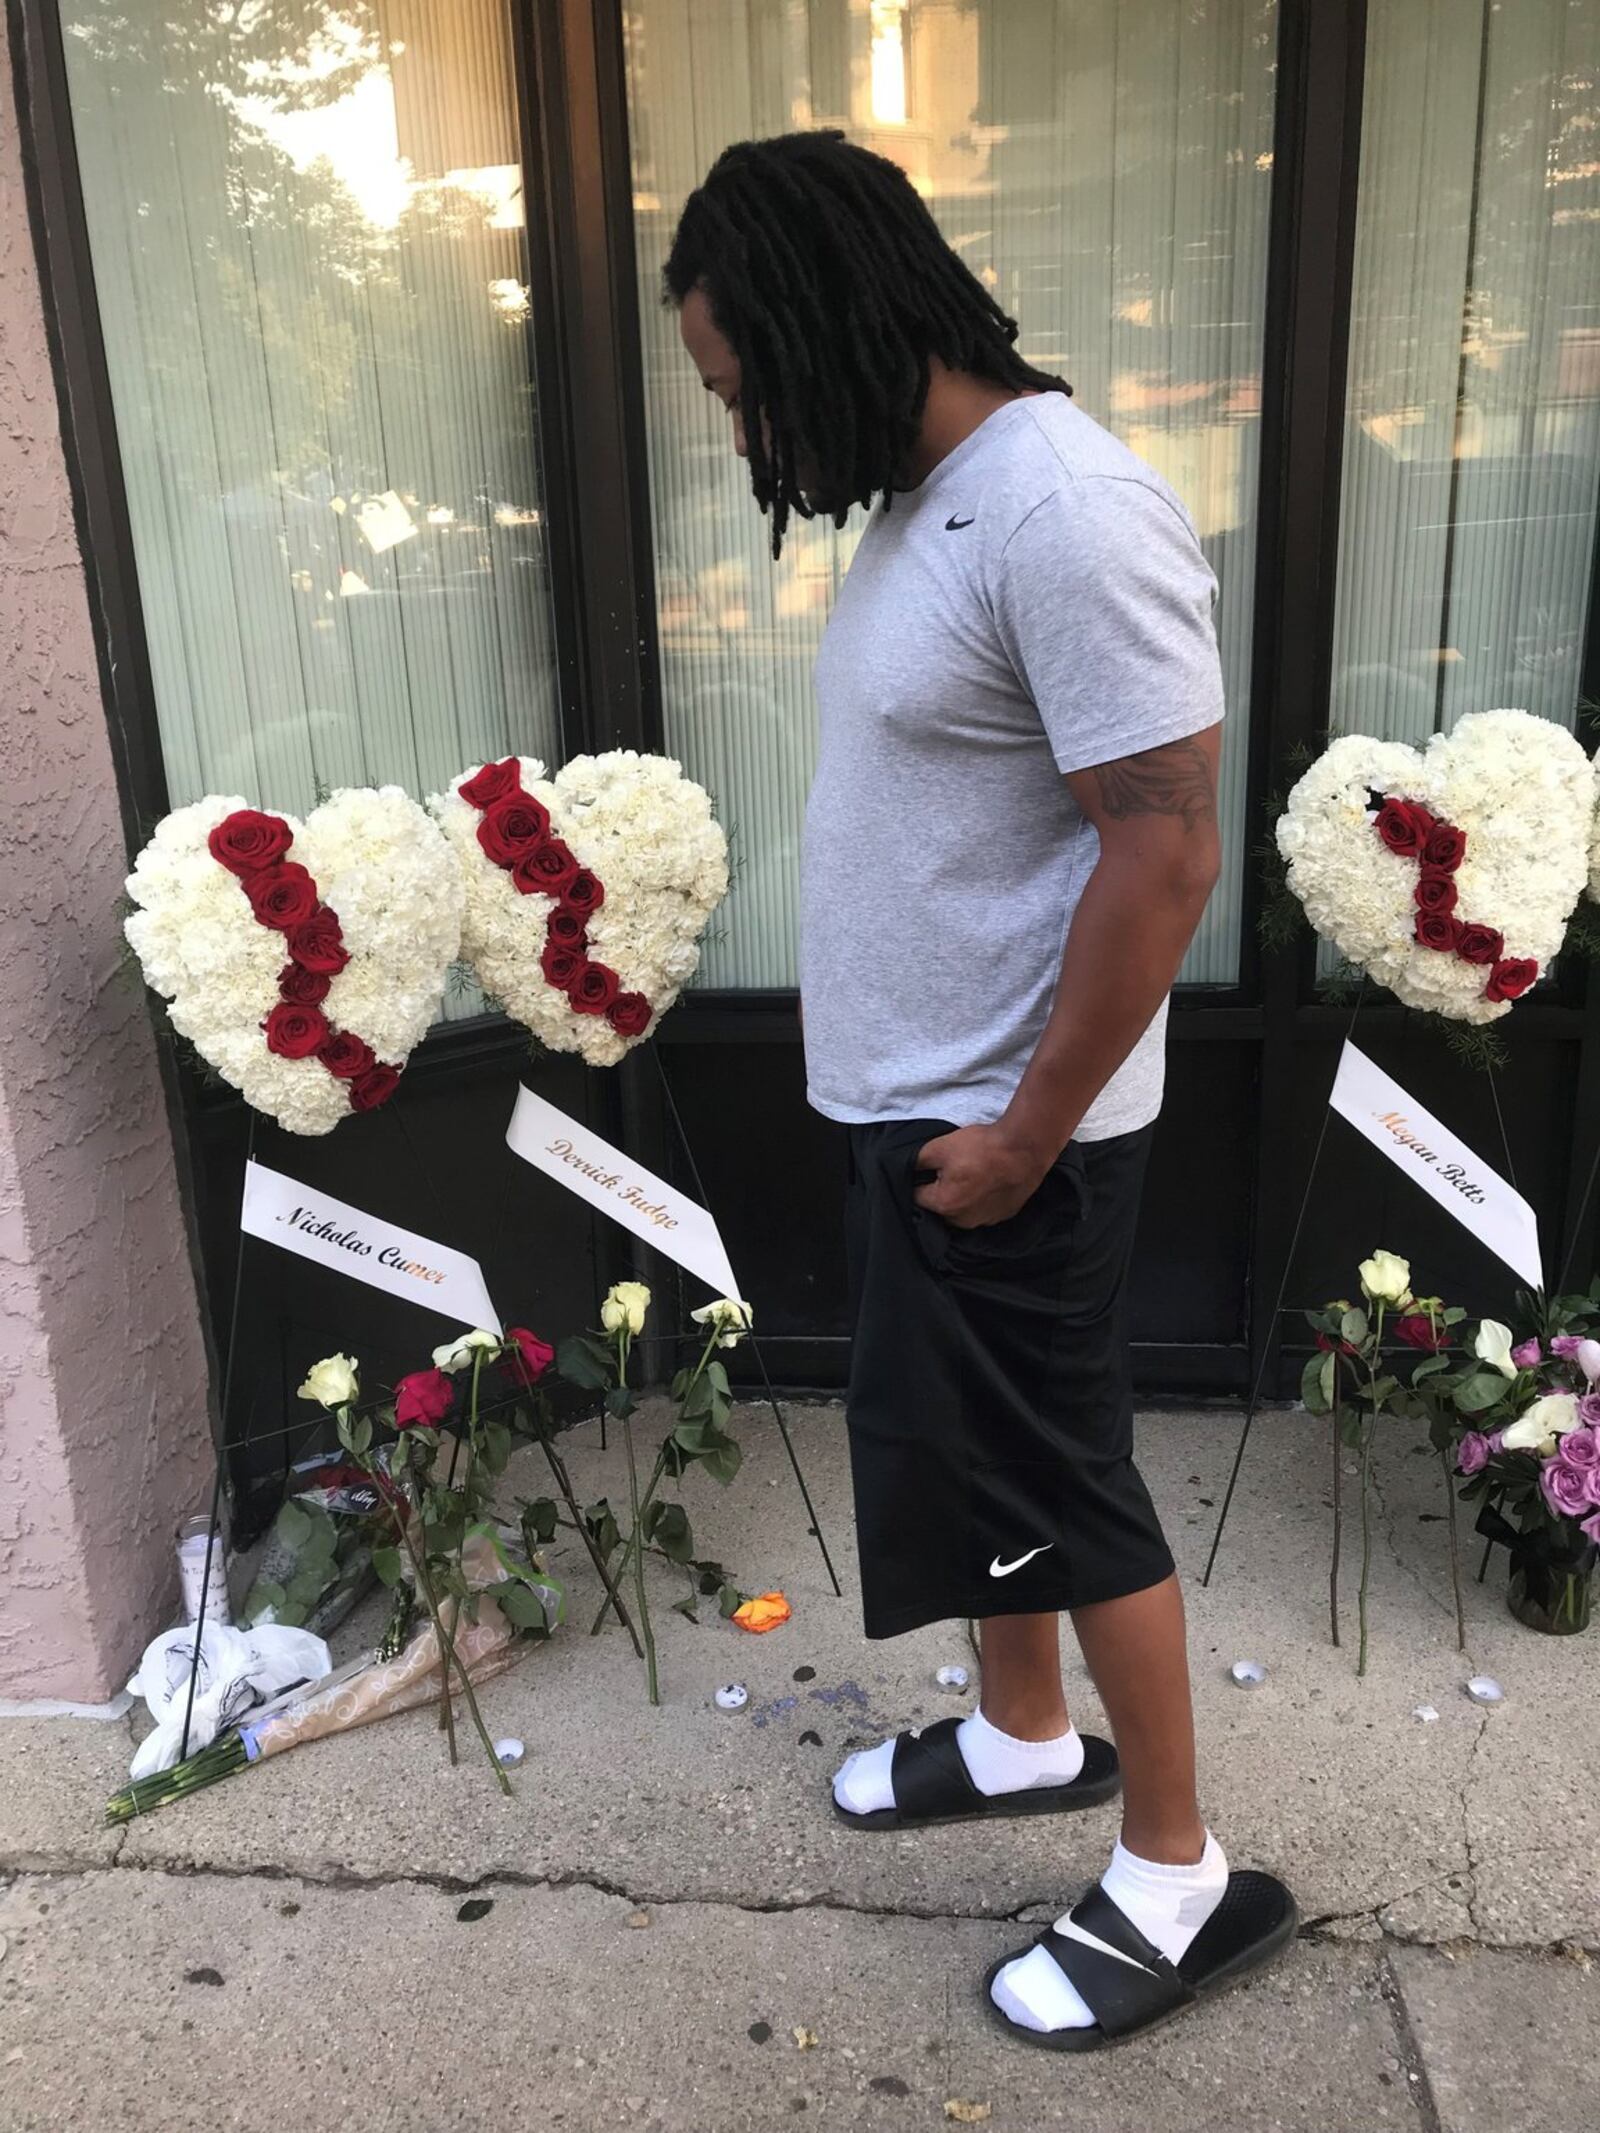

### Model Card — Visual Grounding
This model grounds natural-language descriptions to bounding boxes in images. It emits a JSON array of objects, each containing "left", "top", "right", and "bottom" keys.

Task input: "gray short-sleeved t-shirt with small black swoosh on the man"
[{"left": 800, "top": 392, "right": 1222, "bottom": 1141}]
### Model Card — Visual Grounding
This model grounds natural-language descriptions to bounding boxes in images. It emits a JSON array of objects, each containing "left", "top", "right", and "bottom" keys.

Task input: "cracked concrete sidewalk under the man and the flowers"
[{"left": 0, "top": 1408, "right": 1600, "bottom": 2133}]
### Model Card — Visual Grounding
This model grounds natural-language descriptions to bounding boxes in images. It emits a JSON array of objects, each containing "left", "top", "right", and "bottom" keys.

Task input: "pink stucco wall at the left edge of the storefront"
[{"left": 0, "top": 38, "right": 209, "bottom": 1702}]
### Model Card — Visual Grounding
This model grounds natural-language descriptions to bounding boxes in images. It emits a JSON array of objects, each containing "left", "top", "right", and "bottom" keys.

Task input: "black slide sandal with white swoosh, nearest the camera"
[{"left": 983, "top": 1873, "right": 1299, "bottom": 2052}]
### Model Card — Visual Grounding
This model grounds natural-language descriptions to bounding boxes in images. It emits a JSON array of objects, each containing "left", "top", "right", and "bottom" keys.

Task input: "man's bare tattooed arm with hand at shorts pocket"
[{"left": 917, "top": 725, "right": 1220, "bottom": 1229}]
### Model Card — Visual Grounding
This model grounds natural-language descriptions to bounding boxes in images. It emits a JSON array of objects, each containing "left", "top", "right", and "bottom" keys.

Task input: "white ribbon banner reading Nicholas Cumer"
[{"left": 239, "top": 1160, "right": 501, "bottom": 1333}]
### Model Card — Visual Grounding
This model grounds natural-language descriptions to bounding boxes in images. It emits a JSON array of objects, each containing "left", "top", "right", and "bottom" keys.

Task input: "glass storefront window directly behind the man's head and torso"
[{"left": 625, "top": 0, "right": 1276, "bottom": 985}]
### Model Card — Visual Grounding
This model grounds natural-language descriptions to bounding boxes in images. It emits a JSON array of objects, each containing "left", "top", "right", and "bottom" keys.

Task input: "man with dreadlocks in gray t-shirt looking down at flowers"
[{"left": 666, "top": 132, "right": 1295, "bottom": 2050}]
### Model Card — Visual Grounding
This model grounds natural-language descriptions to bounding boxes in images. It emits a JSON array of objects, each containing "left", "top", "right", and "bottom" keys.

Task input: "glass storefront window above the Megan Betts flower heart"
[{"left": 1331, "top": 0, "right": 1600, "bottom": 742}]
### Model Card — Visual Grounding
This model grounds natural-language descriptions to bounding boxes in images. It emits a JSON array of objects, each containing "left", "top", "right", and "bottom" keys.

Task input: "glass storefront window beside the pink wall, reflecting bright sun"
[{"left": 62, "top": 0, "right": 559, "bottom": 1013}]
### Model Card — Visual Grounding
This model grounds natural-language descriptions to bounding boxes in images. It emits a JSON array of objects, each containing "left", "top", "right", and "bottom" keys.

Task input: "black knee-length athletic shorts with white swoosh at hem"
[{"left": 847, "top": 1118, "right": 1173, "bottom": 1636}]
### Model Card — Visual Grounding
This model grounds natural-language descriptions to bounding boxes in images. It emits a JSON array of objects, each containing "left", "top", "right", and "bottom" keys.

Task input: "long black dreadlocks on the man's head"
[{"left": 663, "top": 130, "right": 1071, "bottom": 557}]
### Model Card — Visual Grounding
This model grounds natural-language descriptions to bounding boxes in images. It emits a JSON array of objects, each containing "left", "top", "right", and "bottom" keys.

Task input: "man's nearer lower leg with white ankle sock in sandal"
[{"left": 986, "top": 1576, "right": 1229, "bottom": 2031}]
